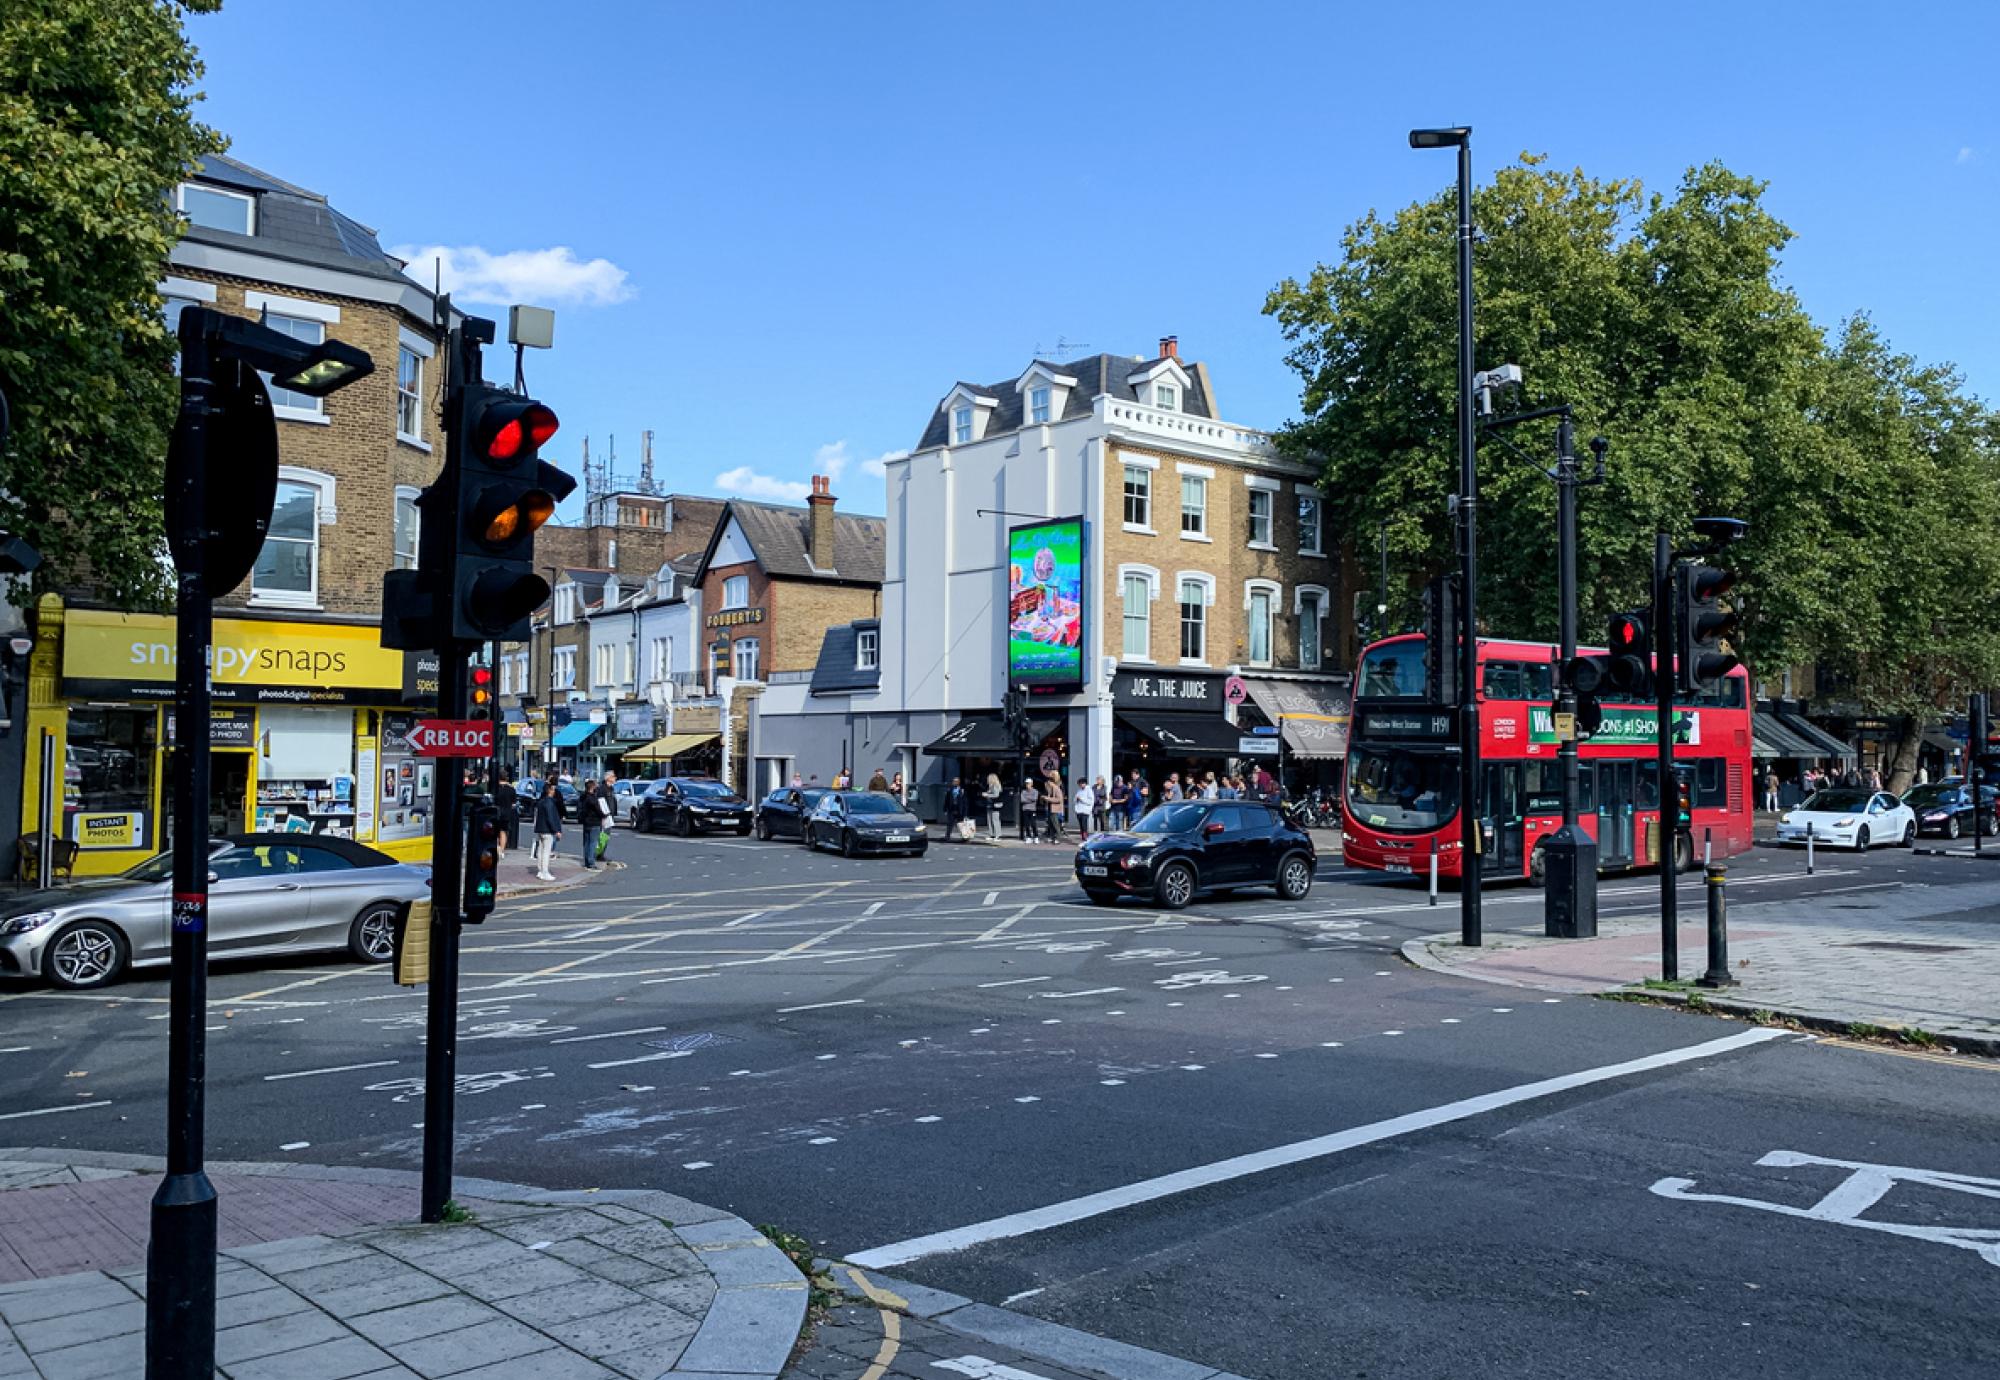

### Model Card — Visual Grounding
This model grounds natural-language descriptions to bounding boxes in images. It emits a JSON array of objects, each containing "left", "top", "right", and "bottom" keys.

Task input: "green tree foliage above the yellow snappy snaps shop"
[{"left": 0, "top": 0, "right": 222, "bottom": 606}]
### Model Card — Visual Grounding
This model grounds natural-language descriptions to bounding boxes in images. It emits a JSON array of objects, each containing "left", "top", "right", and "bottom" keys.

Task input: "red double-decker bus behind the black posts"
[{"left": 1340, "top": 634, "right": 1754, "bottom": 880}]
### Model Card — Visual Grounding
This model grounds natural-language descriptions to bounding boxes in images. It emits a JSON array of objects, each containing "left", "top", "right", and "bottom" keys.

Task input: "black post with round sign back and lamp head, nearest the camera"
[{"left": 146, "top": 306, "right": 374, "bottom": 1380}]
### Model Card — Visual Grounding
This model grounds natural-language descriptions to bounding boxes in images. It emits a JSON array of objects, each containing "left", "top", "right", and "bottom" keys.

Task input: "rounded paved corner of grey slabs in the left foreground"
[{"left": 0, "top": 1148, "right": 808, "bottom": 1380}]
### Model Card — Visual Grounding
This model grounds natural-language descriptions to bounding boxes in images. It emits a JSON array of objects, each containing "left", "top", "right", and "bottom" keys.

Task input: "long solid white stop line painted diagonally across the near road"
[{"left": 846, "top": 1026, "right": 1790, "bottom": 1270}]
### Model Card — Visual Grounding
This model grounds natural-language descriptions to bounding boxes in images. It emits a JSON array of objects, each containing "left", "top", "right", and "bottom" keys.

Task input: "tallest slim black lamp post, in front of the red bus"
[{"left": 1410, "top": 124, "right": 1484, "bottom": 946}]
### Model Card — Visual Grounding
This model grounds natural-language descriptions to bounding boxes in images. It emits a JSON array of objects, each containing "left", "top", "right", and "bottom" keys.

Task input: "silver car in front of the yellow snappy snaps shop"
[{"left": 0, "top": 834, "right": 430, "bottom": 990}]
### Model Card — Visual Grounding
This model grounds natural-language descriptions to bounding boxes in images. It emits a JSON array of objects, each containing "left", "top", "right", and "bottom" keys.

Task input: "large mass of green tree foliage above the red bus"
[{"left": 1264, "top": 154, "right": 2000, "bottom": 718}]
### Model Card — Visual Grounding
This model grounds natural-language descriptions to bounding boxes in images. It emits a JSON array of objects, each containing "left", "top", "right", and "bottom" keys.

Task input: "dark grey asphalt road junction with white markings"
[{"left": 0, "top": 832, "right": 2000, "bottom": 1380}]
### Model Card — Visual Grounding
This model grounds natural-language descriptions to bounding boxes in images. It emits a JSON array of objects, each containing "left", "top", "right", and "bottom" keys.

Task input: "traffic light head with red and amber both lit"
[{"left": 448, "top": 384, "right": 576, "bottom": 642}]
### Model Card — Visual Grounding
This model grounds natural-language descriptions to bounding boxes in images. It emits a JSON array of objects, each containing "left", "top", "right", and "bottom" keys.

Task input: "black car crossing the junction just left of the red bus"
[{"left": 1076, "top": 800, "right": 1318, "bottom": 910}]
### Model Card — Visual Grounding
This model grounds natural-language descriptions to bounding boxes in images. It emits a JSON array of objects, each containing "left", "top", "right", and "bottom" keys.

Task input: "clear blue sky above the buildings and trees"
[{"left": 190, "top": 0, "right": 2000, "bottom": 512}]
